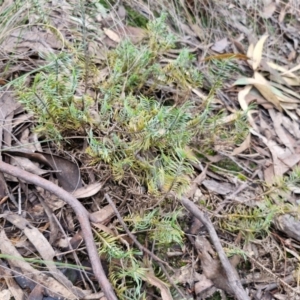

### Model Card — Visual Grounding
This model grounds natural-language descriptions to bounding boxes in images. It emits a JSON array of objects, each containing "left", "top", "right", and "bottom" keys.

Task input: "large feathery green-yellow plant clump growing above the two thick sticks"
[{"left": 14, "top": 16, "right": 209, "bottom": 194}]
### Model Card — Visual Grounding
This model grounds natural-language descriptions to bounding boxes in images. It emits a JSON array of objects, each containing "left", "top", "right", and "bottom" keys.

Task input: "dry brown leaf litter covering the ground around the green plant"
[{"left": 0, "top": 1, "right": 300, "bottom": 299}]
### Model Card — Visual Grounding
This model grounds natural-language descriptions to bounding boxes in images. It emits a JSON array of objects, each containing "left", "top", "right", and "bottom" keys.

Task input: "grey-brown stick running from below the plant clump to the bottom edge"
[{"left": 179, "top": 197, "right": 250, "bottom": 300}]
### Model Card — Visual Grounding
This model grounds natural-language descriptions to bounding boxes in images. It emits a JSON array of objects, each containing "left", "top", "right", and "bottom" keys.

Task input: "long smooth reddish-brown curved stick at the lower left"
[{"left": 0, "top": 160, "right": 118, "bottom": 300}]
